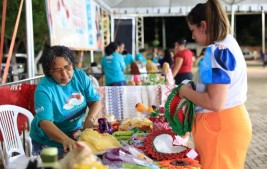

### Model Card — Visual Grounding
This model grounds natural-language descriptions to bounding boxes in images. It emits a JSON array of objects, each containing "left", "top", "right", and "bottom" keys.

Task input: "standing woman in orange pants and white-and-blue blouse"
[{"left": 179, "top": 0, "right": 252, "bottom": 169}]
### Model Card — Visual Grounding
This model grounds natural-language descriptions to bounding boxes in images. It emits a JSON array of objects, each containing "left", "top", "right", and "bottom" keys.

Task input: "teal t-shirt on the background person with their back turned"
[{"left": 101, "top": 52, "right": 126, "bottom": 85}]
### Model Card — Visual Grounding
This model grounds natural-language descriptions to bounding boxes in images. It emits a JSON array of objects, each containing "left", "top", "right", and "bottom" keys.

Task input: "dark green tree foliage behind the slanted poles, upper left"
[{"left": 0, "top": 0, "right": 49, "bottom": 53}]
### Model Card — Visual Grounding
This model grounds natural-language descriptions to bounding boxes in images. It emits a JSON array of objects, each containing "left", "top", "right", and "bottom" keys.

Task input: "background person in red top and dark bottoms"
[{"left": 172, "top": 38, "right": 194, "bottom": 85}]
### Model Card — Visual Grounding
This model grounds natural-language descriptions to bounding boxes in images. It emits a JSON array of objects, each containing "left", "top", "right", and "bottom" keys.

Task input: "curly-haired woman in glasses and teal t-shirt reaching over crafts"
[{"left": 30, "top": 46, "right": 101, "bottom": 157}]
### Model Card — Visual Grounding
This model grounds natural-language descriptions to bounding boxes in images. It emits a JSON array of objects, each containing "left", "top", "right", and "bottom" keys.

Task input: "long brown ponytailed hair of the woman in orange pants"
[{"left": 186, "top": 0, "right": 230, "bottom": 44}]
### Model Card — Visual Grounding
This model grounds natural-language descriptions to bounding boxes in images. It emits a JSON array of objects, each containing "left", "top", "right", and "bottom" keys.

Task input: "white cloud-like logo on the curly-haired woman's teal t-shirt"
[{"left": 63, "top": 92, "right": 84, "bottom": 110}]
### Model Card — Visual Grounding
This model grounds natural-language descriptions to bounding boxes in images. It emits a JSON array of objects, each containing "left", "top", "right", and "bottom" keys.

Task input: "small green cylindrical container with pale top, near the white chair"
[{"left": 40, "top": 147, "right": 60, "bottom": 169}]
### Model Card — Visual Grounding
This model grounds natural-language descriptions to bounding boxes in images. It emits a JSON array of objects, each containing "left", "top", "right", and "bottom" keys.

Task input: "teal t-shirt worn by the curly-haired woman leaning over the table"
[{"left": 30, "top": 69, "right": 100, "bottom": 147}]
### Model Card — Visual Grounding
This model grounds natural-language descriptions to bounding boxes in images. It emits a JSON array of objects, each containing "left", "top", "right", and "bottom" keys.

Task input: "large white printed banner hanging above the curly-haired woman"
[{"left": 46, "top": 0, "right": 100, "bottom": 50}]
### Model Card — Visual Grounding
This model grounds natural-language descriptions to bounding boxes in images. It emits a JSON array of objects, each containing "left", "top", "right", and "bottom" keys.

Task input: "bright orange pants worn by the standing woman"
[{"left": 192, "top": 105, "right": 252, "bottom": 169}]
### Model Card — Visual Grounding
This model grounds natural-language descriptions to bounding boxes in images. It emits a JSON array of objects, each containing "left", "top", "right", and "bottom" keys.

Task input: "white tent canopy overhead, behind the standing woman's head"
[{"left": 99, "top": 0, "right": 267, "bottom": 16}]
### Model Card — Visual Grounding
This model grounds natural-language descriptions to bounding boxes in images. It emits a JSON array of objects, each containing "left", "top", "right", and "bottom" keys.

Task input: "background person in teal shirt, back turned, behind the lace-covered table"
[{"left": 101, "top": 42, "right": 126, "bottom": 86}]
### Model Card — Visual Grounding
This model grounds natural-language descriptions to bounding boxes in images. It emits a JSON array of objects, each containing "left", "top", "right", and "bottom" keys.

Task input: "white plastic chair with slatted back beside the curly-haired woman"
[{"left": 0, "top": 105, "right": 33, "bottom": 169}]
